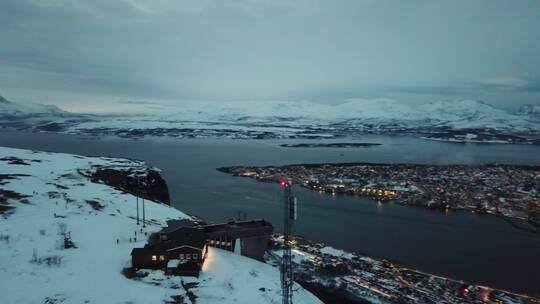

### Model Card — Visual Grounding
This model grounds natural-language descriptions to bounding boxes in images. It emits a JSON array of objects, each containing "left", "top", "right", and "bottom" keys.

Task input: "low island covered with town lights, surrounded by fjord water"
[{"left": 218, "top": 163, "right": 540, "bottom": 231}]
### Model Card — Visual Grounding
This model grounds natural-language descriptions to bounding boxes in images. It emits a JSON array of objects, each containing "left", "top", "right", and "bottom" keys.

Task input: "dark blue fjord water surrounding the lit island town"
[{"left": 0, "top": 130, "right": 540, "bottom": 296}]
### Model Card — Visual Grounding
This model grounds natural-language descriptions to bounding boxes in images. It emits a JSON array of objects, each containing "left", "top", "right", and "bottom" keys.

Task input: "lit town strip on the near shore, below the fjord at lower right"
[{"left": 266, "top": 237, "right": 540, "bottom": 304}]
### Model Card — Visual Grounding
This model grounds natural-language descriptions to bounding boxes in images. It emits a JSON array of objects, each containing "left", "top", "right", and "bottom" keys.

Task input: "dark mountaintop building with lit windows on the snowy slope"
[{"left": 131, "top": 220, "right": 274, "bottom": 276}]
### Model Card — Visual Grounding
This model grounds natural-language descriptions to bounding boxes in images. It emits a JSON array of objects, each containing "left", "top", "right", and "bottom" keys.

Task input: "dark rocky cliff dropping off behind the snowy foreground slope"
[{"left": 91, "top": 168, "right": 171, "bottom": 205}]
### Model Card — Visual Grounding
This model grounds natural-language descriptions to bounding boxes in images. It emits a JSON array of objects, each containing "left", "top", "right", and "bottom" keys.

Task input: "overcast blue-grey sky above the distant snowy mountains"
[{"left": 0, "top": 0, "right": 540, "bottom": 111}]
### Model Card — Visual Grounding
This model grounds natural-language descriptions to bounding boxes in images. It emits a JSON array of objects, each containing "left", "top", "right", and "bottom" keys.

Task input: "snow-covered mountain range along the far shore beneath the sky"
[{"left": 0, "top": 98, "right": 540, "bottom": 143}]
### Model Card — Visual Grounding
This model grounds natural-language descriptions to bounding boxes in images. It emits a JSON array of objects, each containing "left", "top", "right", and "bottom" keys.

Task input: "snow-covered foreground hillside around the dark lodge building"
[{"left": 0, "top": 147, "right": 320, "bottom": 304}]
